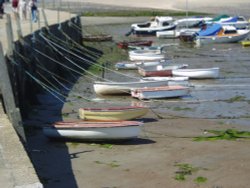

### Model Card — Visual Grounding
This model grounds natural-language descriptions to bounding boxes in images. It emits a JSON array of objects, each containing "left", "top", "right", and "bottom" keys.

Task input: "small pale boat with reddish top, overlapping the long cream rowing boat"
[{"left": 131, "top": 86, "right": 189, "bottom": 99}]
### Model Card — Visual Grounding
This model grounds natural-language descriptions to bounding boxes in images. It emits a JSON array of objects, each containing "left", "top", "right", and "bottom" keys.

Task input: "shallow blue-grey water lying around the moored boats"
[{"left": 73, "top": 24, "right": 250, "bottom": 125}]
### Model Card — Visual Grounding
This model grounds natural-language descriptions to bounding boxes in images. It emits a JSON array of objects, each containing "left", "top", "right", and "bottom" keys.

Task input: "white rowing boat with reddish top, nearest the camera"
[{"left": 43, "top": 121, "right": 143, "bottom": 141}]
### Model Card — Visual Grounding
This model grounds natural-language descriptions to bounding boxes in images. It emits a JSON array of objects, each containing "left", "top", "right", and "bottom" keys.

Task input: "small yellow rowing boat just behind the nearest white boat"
[{"left": 79, "top": 106, "right": 148, "bottom": 121}]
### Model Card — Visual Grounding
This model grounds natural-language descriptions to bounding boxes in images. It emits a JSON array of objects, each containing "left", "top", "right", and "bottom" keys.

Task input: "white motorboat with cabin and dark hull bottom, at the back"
[{"left": 131, "top": 16, "right": 176, "bottom": 36}]
